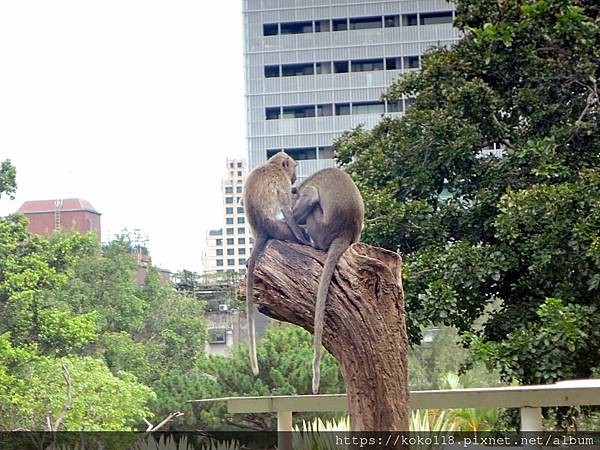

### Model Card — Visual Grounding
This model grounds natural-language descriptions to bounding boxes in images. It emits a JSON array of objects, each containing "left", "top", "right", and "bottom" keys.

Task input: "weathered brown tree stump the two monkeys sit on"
[{"left": 241, "top": 240, "right": 410, "bottom": 431}]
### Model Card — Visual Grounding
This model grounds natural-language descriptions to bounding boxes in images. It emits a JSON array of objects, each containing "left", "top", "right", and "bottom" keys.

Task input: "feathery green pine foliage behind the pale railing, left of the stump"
[{"left": 169, "top": 324, "right": 344, "bottom": 430}]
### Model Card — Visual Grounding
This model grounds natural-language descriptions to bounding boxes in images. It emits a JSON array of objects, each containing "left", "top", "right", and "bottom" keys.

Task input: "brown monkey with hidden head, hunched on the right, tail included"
[{"left": 292, "top": 168, "right": 365, "bottom": 394}]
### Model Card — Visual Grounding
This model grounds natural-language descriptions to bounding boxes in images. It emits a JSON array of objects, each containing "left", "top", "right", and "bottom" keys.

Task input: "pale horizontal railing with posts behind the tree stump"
[{"left": 191, "top": 380, "right": 600, "bottom": 431}]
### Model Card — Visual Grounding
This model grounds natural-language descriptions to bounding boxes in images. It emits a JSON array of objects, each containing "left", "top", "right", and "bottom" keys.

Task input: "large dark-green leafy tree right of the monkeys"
[{"left": 335, "top": 0, "right": 600, "bottom": 383}]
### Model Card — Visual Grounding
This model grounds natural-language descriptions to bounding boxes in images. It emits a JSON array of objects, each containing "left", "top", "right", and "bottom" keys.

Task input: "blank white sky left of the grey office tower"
[{"left": 0, "top": 0, "right": 246, "bottom": 272}]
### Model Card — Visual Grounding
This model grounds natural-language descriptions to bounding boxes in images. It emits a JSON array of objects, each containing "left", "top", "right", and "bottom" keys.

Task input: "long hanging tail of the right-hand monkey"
[{"left": 312, "top": 238, "right": 350, "bottom": 394}]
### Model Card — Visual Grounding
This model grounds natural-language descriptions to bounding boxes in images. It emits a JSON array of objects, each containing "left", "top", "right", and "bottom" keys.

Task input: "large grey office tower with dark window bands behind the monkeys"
[{"left": 243, "top": 0, "right": 458, "bottom": 180}]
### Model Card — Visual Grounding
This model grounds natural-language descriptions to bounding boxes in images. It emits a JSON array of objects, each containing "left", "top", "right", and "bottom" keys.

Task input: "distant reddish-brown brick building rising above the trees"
[{"left": 19, "top": 198, "right": 100, "bottom": 239}]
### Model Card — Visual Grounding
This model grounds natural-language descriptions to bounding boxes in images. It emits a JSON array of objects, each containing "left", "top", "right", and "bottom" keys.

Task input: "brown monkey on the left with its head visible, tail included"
[{"left": 244, "top": 152, "right": 308, "bottom": 375}]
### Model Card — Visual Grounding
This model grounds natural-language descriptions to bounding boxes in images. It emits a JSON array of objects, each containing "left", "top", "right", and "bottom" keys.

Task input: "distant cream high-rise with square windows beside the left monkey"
[{"left": 204, "top": 159, "right": 254, "bottom": 273}]
